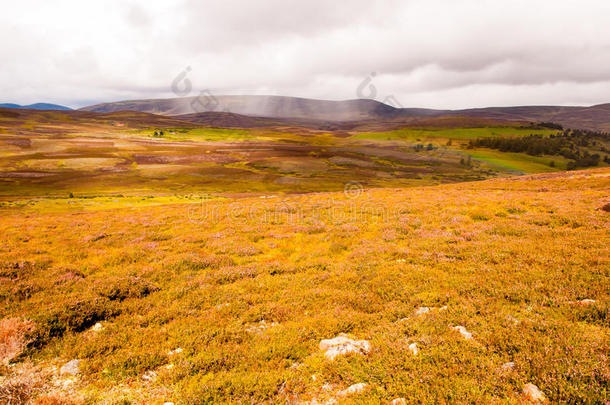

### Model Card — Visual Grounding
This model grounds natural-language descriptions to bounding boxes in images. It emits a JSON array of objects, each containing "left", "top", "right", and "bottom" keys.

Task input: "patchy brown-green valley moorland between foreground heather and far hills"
[{"left": 0, "top": 105, "right": 605, "bottom": 198}]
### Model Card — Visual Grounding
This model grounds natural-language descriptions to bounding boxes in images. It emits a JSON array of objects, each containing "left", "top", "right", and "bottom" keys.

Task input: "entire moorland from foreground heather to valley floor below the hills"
[{"left": 0, "top": 106, "right": 610, "bottom": 404}]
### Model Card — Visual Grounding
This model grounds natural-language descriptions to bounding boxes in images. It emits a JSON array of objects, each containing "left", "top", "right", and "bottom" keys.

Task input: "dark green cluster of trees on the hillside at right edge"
[{"left": 468, "top": 129, "right": 610, "bottom": 170}]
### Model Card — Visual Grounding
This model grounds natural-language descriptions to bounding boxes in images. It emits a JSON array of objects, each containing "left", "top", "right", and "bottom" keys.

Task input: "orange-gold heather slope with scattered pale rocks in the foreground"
[{"left": 0, "top": 169, "right": 610, "bottom": 403}]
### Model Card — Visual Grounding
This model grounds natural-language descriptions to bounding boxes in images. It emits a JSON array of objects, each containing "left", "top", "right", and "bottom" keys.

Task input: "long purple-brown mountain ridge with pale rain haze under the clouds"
[{"left": 82, "top": 95, "right": 610, "bottom": 132}]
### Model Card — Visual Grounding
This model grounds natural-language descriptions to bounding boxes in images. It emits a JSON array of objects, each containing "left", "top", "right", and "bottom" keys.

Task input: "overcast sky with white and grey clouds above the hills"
[{"left": 0, "top": 0, "right": 610, "bottom": 108}]
